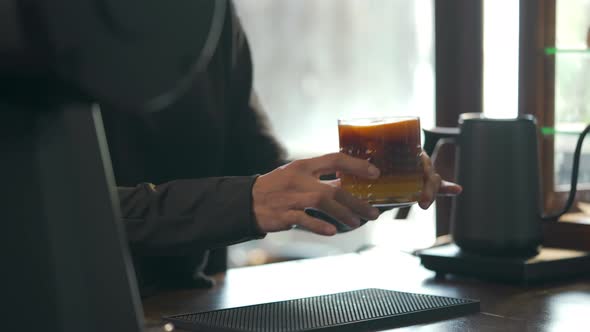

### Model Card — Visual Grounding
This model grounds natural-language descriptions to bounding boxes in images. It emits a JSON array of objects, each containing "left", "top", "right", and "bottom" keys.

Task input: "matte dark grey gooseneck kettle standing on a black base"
[{"left": 424, "top": 113, "right": 590, "bottom": 256}]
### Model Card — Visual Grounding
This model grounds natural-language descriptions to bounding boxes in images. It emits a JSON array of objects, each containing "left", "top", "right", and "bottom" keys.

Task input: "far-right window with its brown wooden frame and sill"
[{"left": 519, "top": 0, "right": 590, "bottom": 250}]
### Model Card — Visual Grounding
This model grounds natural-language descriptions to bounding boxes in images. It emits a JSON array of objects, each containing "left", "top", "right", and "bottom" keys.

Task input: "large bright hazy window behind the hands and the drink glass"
[{"left": 229, "top": 0, "right": 435, "bottom": 266}]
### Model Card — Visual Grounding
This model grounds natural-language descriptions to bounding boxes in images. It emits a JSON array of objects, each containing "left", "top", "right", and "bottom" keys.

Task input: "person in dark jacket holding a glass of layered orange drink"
[{"left": 103, "top": 1, "right": 461, "bottom": 296}]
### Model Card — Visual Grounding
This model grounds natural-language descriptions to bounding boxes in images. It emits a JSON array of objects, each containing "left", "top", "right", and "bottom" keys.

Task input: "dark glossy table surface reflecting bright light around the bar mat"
[{"left": 144, "top": 248, "right": 590, "bottom": 331}]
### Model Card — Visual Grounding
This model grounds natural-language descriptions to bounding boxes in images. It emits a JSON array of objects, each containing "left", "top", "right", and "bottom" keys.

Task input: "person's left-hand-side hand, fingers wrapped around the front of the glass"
[{"left": 252, "top": 153, "right": 379, "bottom": 235}]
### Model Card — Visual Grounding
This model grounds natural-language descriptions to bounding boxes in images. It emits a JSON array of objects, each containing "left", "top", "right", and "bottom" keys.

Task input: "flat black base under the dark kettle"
[{"left": 418, "top": 244, "right": 590, "bottom": 285}]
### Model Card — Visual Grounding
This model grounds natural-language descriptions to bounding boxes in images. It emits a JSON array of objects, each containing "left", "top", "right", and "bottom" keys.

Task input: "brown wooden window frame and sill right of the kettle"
[{"left": 519, "top": 0, "right": 590, "bottom": 250}]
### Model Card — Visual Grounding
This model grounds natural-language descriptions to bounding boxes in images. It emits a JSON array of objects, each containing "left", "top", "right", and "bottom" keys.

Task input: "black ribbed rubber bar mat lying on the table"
[{"left": 164, "top": 288, "right": 479, "bottom": 332}]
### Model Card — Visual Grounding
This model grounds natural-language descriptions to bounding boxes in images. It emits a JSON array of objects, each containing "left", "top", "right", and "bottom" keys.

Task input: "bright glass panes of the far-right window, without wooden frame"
[{"left": 548, "top": 0, "right": 590, "bottom": 187}]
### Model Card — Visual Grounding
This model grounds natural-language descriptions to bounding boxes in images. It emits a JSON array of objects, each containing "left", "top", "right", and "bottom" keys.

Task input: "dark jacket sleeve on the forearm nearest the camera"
[{"left": 118, "top": 176, "right": 264, "bottom": 256}]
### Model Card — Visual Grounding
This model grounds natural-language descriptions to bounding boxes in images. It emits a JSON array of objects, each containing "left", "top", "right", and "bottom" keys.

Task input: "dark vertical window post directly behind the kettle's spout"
[{"left": 434, "top": 0, "right": 483, "bottom": 236}]
